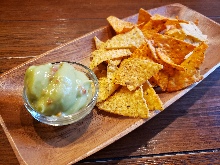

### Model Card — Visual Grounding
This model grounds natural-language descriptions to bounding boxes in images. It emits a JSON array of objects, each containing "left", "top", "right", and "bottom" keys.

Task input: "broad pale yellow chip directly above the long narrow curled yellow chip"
[{"left": 106, "top": 27, "right": 145, "bottom": 49}]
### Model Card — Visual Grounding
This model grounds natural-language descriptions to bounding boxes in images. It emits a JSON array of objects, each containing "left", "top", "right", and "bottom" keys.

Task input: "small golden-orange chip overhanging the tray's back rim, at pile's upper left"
[{"left": 107, "top": 16, "right": 135, "bottom": 34}]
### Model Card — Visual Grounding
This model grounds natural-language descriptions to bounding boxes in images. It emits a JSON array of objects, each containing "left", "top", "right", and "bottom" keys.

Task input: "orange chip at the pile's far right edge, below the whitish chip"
[{"left": 167, "top": 42, "right": 207, "bottom": 92}]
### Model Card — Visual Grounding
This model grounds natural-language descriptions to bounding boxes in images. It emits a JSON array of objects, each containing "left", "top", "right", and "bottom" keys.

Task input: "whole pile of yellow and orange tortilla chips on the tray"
[{"left": 90, "top": 8, "right": 208, "bottom": 118}]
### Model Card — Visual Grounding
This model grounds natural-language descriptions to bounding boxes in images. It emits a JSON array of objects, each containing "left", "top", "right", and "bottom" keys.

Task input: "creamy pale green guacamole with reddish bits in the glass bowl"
[{"left": 24, "top": 62, "right": 92, "bottom": 116}]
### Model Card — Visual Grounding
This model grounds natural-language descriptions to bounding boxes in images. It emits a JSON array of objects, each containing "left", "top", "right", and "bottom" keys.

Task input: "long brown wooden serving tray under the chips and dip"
[{"left": 0, "top": 4, "right": 220, "bottom": 165}]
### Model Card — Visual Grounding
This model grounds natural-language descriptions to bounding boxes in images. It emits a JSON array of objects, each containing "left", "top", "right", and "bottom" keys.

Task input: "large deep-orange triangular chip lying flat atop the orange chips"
[{"left": 149, "top": 33, "right": 195, "bottom": 64}]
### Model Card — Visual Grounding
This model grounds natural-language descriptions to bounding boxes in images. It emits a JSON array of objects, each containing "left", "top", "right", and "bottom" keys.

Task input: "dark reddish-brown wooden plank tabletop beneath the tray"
[{"left": 0, "top": 0, "right": 220, "bottom": 164}]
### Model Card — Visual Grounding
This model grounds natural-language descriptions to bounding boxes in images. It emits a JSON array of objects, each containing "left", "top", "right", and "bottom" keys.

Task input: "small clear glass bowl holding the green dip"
[{"left": 23, "top": 61, "right": 99, "bottom": 126}]
